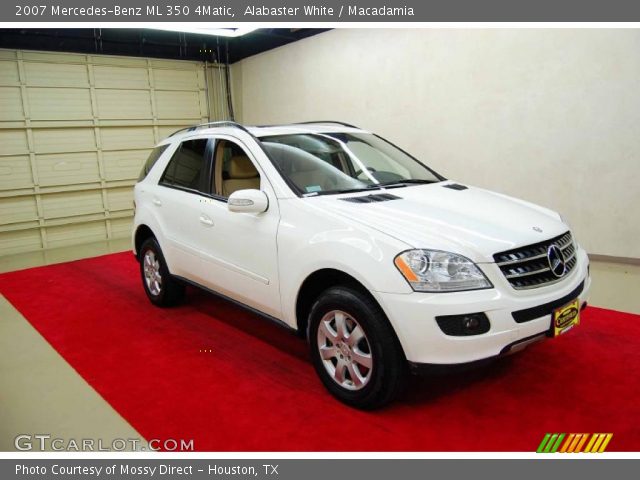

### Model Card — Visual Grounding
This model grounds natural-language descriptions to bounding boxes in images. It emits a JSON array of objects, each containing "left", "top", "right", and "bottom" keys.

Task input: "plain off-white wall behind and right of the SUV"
[{"left": 232, "top": 29, "right": 640, "bottom": 258}]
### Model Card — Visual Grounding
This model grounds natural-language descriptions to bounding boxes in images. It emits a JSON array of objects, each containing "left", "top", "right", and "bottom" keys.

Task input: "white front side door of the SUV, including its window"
[{"left": 190, "top": 138, "right": 281, "bottom": 318}]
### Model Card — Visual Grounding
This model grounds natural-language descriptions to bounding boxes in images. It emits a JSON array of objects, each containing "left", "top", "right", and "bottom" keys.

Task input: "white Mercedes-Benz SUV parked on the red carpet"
[{"left": 133, "top": 122, "right": 590, "bottom": 409}]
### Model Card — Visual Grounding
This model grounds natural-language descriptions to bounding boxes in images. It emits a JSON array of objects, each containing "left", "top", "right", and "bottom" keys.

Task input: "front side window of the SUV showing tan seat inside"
[{"left": 211, "top": 140, "right": 260, "bottom": 198}]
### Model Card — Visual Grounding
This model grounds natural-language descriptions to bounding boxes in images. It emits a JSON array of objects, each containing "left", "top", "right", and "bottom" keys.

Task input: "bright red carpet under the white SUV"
[{"left": 0, "top": 253, "right": 640, "bottom": 452}]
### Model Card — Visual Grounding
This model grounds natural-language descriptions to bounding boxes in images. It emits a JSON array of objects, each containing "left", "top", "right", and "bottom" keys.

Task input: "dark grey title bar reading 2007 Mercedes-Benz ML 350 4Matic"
[{"left": 0, "top": 0, "right": 640, "bottom": 23}]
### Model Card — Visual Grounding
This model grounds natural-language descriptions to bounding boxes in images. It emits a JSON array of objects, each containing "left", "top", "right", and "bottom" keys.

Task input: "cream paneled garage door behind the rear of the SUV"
[{"left": 0, "top": 50, "right": 211, "bottom": 256}]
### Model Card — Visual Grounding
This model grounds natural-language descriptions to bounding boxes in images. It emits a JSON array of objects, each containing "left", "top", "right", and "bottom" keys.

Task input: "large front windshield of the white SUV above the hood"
[{"left": 260, "top": 133, "right": 443, "bottom": 195}]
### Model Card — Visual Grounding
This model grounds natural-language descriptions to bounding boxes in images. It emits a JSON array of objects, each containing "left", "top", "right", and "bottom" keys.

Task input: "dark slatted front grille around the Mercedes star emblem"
[{"left": 493, "top": 232, "right": 577, "bottom": 290}]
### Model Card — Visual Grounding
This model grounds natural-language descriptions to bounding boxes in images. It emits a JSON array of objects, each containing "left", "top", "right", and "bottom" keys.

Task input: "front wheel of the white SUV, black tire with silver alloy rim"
[{"left": 309, "top": 286, "right": 408, "bottom": 410}]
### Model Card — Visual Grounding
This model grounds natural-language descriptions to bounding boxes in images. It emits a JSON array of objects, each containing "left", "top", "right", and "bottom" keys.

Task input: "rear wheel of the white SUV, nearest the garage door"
[{"left": 138, "top": 237, "right": 185, "bottom": 307}]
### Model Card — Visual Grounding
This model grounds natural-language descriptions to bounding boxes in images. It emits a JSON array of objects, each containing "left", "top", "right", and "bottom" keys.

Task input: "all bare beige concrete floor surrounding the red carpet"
[{"left": 0, "top": 239, "right": 640, "bottom": 451}]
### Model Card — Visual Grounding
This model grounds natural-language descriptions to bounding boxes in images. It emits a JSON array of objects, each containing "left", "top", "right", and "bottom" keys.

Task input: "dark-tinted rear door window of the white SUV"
[{"left": 160, "top": 138, "right": 207, "bottom": 191}]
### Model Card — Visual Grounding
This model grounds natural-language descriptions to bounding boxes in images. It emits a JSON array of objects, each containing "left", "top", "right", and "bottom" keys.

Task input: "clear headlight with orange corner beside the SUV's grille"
[{"left": 394, "top": 250, "right": 493, "bottom": 292}]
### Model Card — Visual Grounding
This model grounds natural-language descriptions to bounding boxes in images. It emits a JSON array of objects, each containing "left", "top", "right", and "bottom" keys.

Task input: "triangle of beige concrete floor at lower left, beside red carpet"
[{"left": 0, "top": 296, "right": 146, "bottom": 451}]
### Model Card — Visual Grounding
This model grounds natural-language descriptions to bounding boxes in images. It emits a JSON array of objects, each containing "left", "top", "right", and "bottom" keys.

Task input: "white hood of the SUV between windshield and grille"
[{"left": 313, "top": 181, "right": 569, "bottom": 263}]
